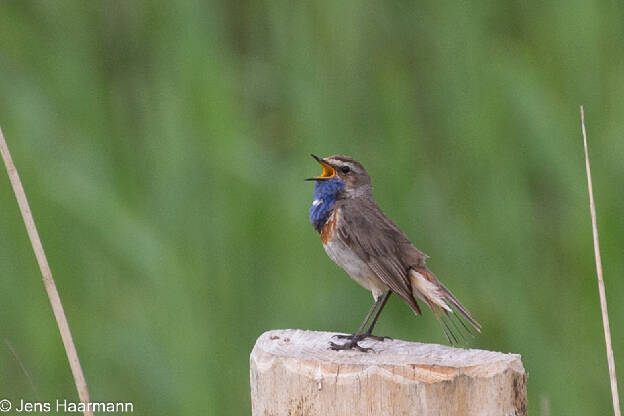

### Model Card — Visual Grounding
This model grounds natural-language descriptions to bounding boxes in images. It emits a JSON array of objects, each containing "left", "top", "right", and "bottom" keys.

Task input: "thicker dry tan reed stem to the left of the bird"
[{"left": 0, "top": 129, "right": 93, "bottom": 416}]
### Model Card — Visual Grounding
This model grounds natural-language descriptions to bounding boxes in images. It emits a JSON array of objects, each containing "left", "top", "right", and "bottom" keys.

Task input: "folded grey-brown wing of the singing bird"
[{"left": 338, "top": 197, "right": 427, "bottom": 315}]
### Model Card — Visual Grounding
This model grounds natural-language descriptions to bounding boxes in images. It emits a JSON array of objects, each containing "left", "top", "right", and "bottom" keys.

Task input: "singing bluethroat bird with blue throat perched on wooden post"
[{"left": 306, "top": 155, "right": 481, "bottom": 351}]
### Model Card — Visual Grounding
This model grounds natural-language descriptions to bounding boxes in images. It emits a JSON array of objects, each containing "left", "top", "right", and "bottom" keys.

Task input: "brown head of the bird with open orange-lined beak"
[{"left": 307, "top": 155, "right": 373, "bottom": 198}]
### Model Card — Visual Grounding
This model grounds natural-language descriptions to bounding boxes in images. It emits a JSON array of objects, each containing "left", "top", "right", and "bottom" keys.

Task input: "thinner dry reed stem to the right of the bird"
[{"left": 581, "top": 106, "right": 621, "bottom": 416}]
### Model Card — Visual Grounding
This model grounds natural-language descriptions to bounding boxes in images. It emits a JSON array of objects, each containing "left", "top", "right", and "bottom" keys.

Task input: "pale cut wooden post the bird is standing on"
[{"left": 250, "top": 329, "right": 527, "bottom": 416}]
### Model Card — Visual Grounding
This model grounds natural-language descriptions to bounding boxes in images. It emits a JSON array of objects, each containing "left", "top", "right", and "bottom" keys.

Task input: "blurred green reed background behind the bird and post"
[{"left": 0, "top": 0, "right": 624, "bottom": 415}]
